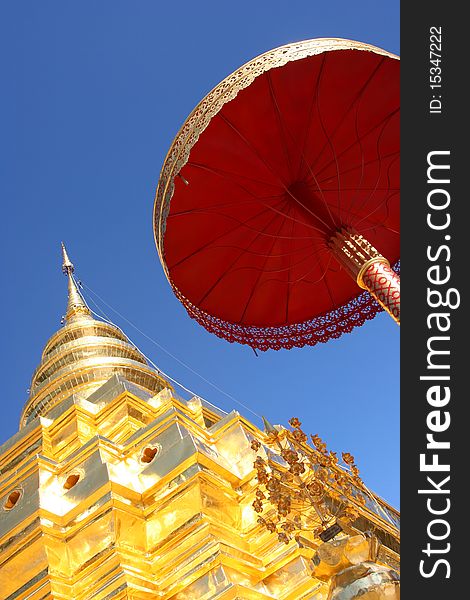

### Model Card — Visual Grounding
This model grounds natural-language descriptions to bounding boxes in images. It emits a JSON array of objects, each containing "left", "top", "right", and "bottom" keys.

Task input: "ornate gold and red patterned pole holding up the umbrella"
[{"left": 329, "top": 229, "right": 400, "bottom": 324}]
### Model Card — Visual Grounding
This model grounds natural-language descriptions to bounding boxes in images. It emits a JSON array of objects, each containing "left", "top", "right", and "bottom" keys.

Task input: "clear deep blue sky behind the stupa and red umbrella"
[{"left": 0, "top": 0, "right": 399, "bottom": 505}]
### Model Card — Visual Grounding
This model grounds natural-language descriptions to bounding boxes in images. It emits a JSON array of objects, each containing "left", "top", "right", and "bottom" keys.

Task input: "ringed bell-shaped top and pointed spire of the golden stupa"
[{"left": 20, "top": 244, "right": 171, "bottom": 427}]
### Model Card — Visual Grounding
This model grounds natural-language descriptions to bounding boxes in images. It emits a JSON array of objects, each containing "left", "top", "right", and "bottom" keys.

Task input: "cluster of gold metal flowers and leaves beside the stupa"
[{"left": 251, "top": 417, "right": 365, "bottom": 544}]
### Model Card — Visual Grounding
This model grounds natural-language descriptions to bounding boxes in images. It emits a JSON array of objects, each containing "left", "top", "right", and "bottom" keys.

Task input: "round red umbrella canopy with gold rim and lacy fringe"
[{"left": 154, "top": 39, "right": 400, "bottom": 349}]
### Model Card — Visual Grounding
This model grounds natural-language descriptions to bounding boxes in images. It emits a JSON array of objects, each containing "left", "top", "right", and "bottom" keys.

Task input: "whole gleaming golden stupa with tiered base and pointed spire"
[{"left": 0, "top": 247, "right": 399, "bottom": 600}]
